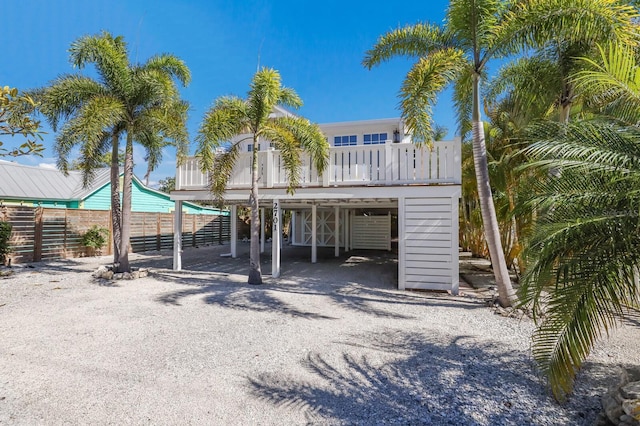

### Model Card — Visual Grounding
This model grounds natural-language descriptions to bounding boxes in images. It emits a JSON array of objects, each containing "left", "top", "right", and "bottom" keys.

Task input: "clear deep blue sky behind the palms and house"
[{"left": 0, "top": 0, "right": 456, "bottom": 186}]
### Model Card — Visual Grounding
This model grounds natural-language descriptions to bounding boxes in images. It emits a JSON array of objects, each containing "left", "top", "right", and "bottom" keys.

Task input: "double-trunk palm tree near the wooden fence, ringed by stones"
[{"left": 35, "top": 32, "right": 190, "bottom": 272}]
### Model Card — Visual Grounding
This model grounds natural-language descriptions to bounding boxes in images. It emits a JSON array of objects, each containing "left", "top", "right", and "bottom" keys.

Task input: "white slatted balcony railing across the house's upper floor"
[{"left": 176, "top": 139, "right": 461, "bottom": 190}]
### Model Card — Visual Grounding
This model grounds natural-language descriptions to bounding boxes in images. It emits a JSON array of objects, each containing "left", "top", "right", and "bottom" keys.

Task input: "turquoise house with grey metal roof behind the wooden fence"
[{"left": 0, "top": 160, "right": 224, "bottom": 215}]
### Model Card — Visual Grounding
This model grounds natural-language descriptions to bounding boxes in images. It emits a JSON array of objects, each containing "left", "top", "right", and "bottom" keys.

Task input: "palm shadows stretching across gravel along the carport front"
[{"left": 153, "top": 262, "right": 484, "bottom": 319}]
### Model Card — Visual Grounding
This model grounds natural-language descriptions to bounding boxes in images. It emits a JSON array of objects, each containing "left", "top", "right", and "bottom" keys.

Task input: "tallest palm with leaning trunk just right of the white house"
[{"left": 363, "top": 0, "right": 633, "bottom": 306}]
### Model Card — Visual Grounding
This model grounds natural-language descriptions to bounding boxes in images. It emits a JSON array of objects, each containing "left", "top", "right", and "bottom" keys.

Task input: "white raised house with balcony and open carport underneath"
[{"left": 171, "top": 109, "right": 461, "bottom": 293}]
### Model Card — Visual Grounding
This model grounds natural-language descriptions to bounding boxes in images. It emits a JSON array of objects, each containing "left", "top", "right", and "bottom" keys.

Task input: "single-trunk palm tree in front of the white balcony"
[{"left": 196, "top": 68, "right": 329, "bottom": 284}]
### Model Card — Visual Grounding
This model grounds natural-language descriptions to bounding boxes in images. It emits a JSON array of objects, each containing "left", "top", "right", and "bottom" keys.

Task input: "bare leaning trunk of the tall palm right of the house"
[{"left": 472, "top": 73, "right": 516, "bottom": 307}]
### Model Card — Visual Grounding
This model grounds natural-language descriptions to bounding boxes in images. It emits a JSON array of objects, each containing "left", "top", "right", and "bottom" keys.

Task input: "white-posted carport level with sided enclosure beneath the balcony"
[{"left": 171, "top": 185, "right": 460, "bottom": 294}]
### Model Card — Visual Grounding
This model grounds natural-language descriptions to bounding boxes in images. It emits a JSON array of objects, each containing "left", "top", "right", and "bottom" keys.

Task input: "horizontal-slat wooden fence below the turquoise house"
[{"left": 0, "top": 206, "right": 231, "bottom": 263}]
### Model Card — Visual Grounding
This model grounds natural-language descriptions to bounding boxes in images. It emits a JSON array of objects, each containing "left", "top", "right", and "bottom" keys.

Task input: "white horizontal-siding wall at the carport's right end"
[{"left": 399, "top": 197, "right": 458, "bottom": 292}]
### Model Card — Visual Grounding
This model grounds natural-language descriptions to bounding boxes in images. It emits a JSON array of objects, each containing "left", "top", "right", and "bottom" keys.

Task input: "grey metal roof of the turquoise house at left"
[{"left": 0, "top": 160, "right": 110, "bottom": 200}]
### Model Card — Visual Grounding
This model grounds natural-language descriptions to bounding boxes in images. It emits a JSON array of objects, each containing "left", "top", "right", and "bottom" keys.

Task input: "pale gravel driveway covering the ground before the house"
[{"left": 0, "top": 244, "right": 640, "bottom": 425}]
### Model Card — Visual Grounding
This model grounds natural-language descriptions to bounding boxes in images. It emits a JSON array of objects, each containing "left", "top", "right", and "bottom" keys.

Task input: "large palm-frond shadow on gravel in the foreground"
[{"left": 247, "top": 330, "right": 604, "bottom": 425}]
